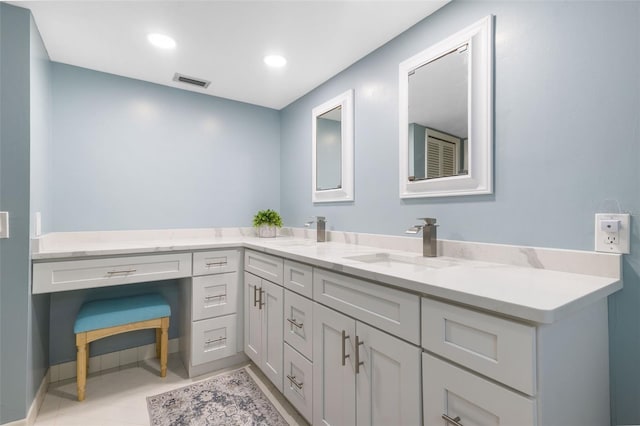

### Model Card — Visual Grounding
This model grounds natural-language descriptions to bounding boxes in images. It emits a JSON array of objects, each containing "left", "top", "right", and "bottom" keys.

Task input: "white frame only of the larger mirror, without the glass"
[{"left": 398, "top": 15, "right": 493, "bottom": 198}]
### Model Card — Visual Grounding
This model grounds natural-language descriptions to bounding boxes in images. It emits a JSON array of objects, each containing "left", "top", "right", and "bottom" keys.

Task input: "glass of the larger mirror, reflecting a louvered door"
[{"left": 408, "top": 43, "right": 469, "bottom": 181}]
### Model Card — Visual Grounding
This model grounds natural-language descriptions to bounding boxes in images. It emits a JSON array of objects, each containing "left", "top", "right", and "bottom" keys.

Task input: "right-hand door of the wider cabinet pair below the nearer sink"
[{"left": 354, "top": 322, "right": 422, "bottom": 426}]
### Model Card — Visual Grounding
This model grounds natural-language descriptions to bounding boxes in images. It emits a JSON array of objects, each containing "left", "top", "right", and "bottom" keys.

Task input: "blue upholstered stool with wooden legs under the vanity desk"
[{"left": 73, "top": 294, "right": 171, "bottom": 401}]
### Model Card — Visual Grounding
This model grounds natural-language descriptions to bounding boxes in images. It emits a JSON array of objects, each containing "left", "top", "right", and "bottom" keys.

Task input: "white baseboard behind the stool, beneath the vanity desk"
[{"left": 49, "top": 338, "right": 180, "bottom": 383}]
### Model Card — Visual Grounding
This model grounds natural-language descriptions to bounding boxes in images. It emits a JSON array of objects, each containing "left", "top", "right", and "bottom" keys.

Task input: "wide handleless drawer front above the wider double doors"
[{"left": 313, "top": 268, "right": 420, "bottom": 345}]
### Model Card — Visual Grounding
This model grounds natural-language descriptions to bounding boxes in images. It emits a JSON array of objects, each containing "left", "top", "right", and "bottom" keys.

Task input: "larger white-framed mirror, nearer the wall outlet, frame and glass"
[{"left": 399, "top": 16, "right": 493, "bottom": 198}]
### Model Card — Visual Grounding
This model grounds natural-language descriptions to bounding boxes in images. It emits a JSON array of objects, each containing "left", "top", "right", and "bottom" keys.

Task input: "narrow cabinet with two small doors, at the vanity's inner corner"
[{"left": 244, "top": 250, "right": 284, "bottom": 392}]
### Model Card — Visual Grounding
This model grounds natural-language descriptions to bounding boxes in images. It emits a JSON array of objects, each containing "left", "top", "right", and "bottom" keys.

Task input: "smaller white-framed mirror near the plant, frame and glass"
[{"left": 311, "top": 90, "right": 353, "bottom": 203}]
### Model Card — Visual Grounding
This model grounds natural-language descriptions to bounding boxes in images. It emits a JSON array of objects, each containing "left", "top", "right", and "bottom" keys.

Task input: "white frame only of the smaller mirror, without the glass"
[{"left": 311, "top": 89, "right": 353, "bottom": 203}]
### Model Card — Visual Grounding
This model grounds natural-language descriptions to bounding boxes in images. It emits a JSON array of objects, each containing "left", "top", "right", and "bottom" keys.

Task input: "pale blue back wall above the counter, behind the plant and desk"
[{"left": 52, "top": 63, "right": 280, "bottom": 231}]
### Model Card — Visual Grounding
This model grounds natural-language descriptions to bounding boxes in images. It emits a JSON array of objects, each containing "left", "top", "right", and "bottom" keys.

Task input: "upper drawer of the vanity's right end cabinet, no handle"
[{"left": 422, "top": 298, "right": 536, "bottom": 395}]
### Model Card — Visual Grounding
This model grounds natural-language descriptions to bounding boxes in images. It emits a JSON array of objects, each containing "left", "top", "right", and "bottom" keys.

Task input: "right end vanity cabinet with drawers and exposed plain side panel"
[{"left": 422, "top": 298, "right": 609, "bottom": 426}]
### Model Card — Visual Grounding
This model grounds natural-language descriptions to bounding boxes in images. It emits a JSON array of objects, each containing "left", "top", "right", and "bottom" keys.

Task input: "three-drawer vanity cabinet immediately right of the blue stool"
[{"left": 180, "top": 249, "right": 242, "bottom": 377}]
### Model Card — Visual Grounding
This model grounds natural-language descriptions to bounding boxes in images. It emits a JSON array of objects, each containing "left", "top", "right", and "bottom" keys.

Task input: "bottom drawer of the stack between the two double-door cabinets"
[{"left": 283, "top": 343, "right": 313, "bottom": 423}]
